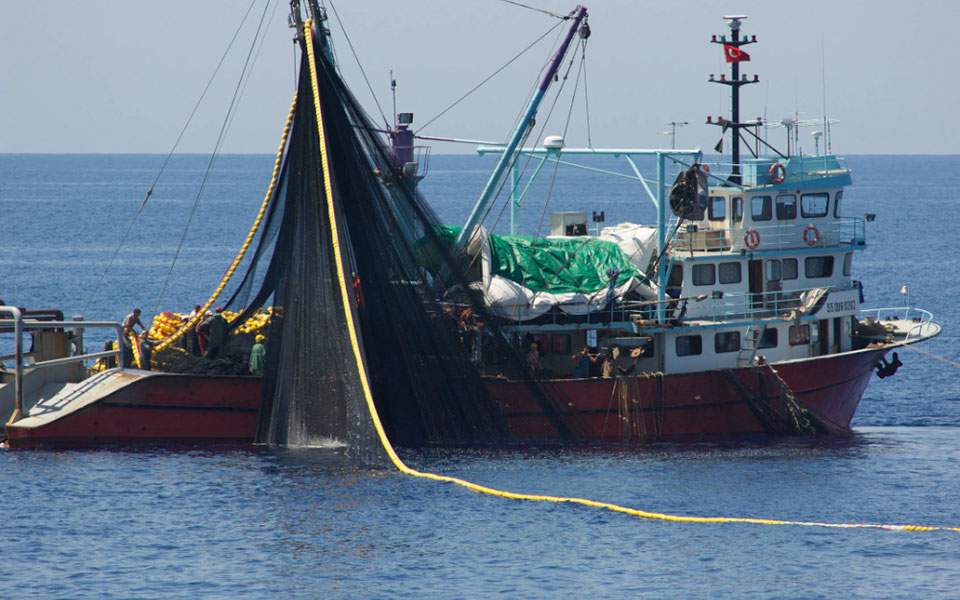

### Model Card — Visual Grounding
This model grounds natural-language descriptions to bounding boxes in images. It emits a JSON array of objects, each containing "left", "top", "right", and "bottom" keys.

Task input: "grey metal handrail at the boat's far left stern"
[{"left": 0, "top": 306, "right": 126, "bottom": 425}]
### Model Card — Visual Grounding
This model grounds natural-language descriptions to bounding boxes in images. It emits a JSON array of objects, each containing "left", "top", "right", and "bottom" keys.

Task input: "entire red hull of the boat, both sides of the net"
[{"left": 1, "top": 349, "right": 886, "bottom": 448}]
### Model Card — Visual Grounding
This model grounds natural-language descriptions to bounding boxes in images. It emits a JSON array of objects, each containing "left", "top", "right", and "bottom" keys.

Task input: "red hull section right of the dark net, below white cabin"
[{"left": 488, "top": 349, "right": 886, "bottom": 443}]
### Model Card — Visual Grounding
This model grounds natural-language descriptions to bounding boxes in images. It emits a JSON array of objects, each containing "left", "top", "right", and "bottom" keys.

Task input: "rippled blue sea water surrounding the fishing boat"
[{"left": 0, "top": 155, "right": 960, "bottom": 598}]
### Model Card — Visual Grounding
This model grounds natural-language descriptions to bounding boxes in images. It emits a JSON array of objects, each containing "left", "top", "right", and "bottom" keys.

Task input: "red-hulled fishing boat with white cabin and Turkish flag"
[{"left": 0, "top": 3, "right": 941, "bottom": 447}]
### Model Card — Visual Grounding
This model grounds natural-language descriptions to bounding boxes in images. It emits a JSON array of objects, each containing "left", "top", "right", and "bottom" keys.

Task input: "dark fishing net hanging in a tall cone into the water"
[{"left": 214, "top": 29, "right": 540, "bottom": 461}]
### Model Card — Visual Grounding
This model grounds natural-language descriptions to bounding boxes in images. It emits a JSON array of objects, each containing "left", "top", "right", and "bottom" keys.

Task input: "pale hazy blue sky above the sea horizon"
[{"left": 0, "top": 0, "right": 960, "bottom": 154}]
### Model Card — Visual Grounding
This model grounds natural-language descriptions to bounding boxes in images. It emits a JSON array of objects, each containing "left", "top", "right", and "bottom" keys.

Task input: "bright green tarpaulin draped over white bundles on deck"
[{"left": 439, "top": 226, "right": 647, "bottom": 294}]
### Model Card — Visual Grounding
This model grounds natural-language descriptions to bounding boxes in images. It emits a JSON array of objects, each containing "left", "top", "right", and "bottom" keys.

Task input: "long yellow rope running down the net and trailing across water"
[{"left": 304, "top": 20, "right": 960, "bottom": 532}]
